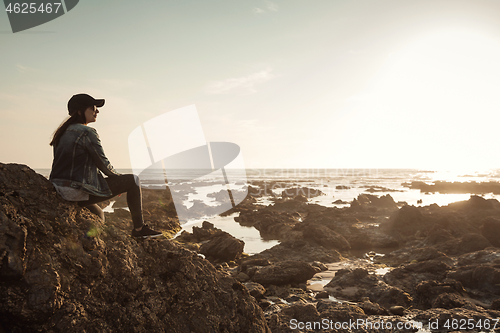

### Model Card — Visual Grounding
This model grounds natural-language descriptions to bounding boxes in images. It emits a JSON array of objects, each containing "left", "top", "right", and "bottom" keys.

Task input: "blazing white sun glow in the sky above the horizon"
[{"left": 340, "top": 29, "right": 500, "bottom": 170}]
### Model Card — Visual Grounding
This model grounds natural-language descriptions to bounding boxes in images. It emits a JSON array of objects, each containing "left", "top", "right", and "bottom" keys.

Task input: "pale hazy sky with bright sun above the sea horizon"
[{"left": 0, "top": 0, "right": 500, "bottom": 169}]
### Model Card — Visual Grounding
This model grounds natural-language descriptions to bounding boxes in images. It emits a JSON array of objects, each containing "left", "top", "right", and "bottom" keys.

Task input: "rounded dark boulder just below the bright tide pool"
[{"left": 200, "top": 233, "right": 245, "bottom": 261}]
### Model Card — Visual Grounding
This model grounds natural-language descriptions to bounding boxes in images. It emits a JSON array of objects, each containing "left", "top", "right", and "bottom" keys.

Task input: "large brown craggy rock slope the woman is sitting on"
[{"left": 0, "top": 164, "right": 269, "bottom": 332}]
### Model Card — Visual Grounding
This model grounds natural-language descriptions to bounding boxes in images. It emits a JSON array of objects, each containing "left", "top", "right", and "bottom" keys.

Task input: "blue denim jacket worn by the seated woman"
[{"left": 49, "top": 124, "right": 119, "bottom": 197}]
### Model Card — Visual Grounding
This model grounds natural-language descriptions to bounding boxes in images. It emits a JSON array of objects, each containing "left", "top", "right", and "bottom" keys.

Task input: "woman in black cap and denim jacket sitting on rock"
[{"left": 49, "top": 94, "right": 161, "bottom": 237}]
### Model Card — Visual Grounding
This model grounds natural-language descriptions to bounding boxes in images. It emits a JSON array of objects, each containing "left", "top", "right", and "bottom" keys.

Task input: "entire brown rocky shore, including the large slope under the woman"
[{"left": 0, "top": 164, "right": 500, "bottom": 332}]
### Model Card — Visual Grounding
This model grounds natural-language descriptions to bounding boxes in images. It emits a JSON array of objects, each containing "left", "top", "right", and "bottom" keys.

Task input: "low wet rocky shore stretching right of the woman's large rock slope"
[{"left": 176, "top": 182, "right": 500, "bottom": 332}]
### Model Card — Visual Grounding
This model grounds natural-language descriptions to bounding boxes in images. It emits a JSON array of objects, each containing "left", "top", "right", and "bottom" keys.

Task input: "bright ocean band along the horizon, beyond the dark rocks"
[{"left": 36, "top": 169, "right": 500, "bottom": 208}]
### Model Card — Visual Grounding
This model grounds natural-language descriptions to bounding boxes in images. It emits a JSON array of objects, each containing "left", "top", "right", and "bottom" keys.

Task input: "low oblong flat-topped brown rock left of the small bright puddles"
[{"left": 252, "top": 260, "right": 316, "bottom": 285}]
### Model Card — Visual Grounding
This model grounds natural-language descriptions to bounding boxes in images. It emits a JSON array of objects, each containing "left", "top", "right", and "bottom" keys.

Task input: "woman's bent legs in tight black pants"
[{"left": 79, "top": 174, "right": 144, "bottom": 229}]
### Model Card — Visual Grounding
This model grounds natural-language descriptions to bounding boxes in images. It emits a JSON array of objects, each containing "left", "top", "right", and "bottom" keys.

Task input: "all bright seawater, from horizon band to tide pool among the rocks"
[{"left": 36, "top": 169, "right": 500, "bottom": 253}]
